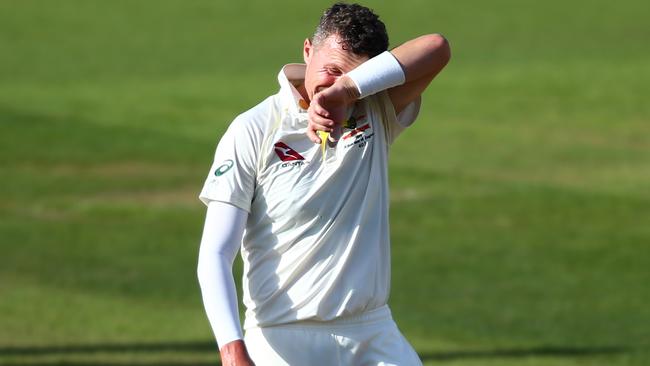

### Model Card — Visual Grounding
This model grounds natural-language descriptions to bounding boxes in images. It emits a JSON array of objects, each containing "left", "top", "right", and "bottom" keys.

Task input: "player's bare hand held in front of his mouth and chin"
[{"left": 307, "top": 76, "right": 359, "bottom": 144}]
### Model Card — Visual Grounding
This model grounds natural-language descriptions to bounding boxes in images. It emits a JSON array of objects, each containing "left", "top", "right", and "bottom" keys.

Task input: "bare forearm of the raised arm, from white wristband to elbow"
[{"left": 390, "top": 34, "right": 451, "bottom": 83}]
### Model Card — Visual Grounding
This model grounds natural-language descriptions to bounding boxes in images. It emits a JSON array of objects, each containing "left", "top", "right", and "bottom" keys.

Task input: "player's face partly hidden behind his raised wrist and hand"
[{"left": 303, "top": 35, "right": 368, "bottom": 101}]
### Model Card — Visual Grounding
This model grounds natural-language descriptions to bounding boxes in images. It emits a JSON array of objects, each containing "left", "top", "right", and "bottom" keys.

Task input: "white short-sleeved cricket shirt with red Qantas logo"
[{"left": 200, "top": 64, "right": 419, "bottom": 328}]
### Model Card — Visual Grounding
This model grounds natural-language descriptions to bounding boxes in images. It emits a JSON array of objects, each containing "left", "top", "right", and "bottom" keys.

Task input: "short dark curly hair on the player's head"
[{"left": 312, "top": 2, "right": 388, "bottom": 57}]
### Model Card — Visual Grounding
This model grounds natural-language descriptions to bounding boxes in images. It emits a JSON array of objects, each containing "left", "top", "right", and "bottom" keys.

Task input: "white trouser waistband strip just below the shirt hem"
[{"left": 252, "top": 305, "right": 393, "bottom": 330}]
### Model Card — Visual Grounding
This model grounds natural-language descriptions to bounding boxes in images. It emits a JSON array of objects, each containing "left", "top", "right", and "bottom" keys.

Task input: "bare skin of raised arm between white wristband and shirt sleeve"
[{"left": 388, "top": 34, "right": 451, "bottom": 114}]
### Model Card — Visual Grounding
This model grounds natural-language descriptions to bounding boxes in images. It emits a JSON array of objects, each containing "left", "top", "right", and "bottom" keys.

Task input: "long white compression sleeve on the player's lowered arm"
[{"left": 197, "top": 201, "right": 248, "bottom": 347}]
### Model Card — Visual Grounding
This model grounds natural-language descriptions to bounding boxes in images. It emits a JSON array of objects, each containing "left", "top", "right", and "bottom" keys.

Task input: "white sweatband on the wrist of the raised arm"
[{"left": 347, "top": 51, "right": 406, "bottom": 99}]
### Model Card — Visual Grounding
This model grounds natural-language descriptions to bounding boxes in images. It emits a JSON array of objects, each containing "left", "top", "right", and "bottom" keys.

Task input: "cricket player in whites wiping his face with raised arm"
[{"left": 198, "top": 3, "right": 450, "bottom": 366}]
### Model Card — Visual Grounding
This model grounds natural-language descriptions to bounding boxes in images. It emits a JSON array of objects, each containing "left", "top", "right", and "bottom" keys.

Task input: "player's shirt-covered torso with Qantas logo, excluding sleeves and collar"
[{"left": 242, "top": 95, "right": 390, "bottom": 324}]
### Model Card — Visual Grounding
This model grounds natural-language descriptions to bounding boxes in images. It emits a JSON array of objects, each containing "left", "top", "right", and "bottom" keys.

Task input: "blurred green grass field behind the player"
[{"left": 0, "top": 0, "right": 650, "bottom": 366}]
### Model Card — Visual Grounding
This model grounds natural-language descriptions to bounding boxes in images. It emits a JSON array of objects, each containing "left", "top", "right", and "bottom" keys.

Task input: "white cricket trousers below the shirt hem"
[{"left": 244, "top": 306, "right": 422, "bottom": 366}]
